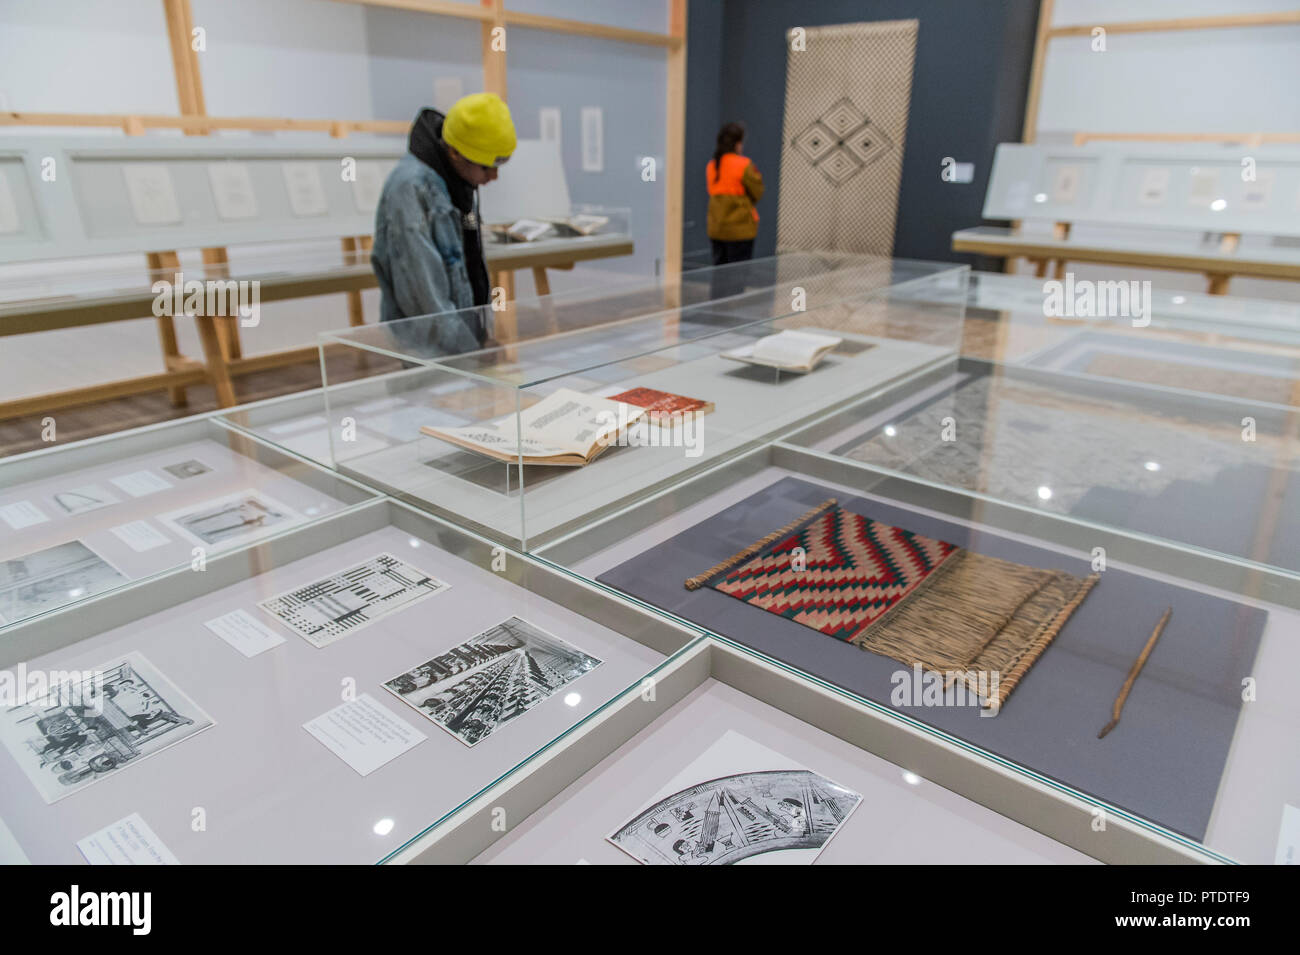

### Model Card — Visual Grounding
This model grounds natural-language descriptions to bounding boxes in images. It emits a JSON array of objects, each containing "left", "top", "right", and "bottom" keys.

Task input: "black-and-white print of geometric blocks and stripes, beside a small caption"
[{"left": 257, "top": 554, "right": 451, "bottom": 647}]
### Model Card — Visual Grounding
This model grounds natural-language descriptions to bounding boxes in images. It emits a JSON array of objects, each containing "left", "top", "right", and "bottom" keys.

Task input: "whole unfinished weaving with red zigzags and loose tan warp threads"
[{"left": 686, "top": 500, "right": 1096, "bottom": 706}]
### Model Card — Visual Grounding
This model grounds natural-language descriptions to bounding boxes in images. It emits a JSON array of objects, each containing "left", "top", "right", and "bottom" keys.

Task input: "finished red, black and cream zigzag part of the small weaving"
[{"left": 712, "top": 507, "right": 957, "bottom": 641}]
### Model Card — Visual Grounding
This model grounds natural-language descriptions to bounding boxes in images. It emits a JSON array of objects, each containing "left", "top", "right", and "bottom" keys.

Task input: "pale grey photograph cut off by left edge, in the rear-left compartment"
[{"left": 0, "top": 541, "right": 129, "bottom": 624}]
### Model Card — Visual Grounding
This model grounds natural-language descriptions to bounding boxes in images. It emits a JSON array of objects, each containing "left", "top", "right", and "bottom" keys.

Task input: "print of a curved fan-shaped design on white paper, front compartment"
[{"left": 610, "top": 730, "right": 862, "bottom": 865}]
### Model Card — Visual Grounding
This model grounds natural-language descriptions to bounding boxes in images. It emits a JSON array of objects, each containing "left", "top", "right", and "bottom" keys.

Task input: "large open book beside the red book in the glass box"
[{"left": 420, "top": 388, "right": 646, "bottom": 468}]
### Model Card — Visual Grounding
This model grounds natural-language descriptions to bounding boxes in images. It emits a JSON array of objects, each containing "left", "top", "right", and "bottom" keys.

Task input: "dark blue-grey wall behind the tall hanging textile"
[{"left": 684, "top": 0, "right": 1039, "bottom": 261}]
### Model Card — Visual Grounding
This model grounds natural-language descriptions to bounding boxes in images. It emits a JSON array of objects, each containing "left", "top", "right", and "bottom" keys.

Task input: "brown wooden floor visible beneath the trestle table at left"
[{"left": 0, "top": 355, "right": 400, "bottom": 457}]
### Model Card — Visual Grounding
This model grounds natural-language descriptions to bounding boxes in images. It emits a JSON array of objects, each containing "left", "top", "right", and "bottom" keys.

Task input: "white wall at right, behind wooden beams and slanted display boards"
[{"left": 1022, "top": 0, "right": 1300, "bottom": 300}]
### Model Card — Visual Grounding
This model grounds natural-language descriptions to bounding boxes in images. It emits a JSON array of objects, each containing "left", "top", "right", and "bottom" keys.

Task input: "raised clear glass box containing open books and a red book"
[{"left": 289, "top": 260, "right": 966, "bottom": 547}]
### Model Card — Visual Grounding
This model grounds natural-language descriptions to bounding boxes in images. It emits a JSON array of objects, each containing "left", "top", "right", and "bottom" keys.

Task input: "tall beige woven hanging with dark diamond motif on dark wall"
[{"left": 776, "top": 19, "right": 918, "bottom": 256}]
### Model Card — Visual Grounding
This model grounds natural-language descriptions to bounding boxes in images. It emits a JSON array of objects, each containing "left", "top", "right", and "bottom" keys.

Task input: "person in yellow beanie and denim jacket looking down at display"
[{"left": 371, "top": 92, "right": 515, "bottom": 356}]
